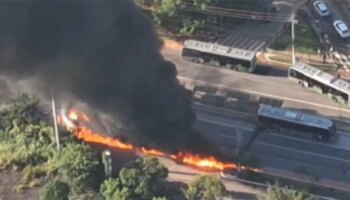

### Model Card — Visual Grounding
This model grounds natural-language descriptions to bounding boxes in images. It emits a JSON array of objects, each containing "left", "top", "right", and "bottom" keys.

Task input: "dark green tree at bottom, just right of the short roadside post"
[{"left": 100, "top": 157, "right": 168, "bottom": 200}]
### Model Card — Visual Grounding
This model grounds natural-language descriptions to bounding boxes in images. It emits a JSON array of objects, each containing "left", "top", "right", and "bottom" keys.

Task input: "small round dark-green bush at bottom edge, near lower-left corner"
[{"left": 40, "top": 179, "right": 70, "bottom": 200}]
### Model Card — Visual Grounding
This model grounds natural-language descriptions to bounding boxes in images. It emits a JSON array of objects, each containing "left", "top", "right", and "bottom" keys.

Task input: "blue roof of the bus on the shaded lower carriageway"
[{"left": 258, "top": 104, "right": 333, "bottom": 129}]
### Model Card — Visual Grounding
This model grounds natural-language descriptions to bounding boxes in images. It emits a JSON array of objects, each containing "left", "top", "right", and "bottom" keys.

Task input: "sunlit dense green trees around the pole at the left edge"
[{"left": 0, "top": 94, "right": 99, "bottom": 199}]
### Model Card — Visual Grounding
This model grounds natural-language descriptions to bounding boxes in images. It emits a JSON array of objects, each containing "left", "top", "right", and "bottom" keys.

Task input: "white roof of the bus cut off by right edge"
[{"left": 291, "top": 62, "right": 350, "bottom": 94}]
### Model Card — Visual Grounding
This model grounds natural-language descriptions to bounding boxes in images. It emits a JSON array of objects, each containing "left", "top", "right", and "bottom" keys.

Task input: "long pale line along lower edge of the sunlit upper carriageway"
[{"left": 177, "top": 76, "right": 350, "bottom": 113}]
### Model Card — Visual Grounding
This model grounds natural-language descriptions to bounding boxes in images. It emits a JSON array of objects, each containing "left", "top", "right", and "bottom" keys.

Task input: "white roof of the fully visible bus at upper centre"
[{"left": 184, "top": 40, "right": 256, "bottom": 61}]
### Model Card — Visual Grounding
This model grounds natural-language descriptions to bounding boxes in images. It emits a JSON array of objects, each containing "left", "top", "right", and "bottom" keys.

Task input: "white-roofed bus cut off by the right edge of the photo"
[{"left": 288, "top": 62, "right": 350, "bottom": 105}]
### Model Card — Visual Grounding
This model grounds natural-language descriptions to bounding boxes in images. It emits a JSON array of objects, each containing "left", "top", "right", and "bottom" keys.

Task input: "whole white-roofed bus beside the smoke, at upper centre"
[{"left": 182, "top": 40, "right": 256, "bottom": 72}]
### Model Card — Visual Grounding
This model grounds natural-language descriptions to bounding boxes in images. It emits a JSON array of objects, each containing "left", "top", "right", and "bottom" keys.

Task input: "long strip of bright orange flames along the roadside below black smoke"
[{"left": 61, "top": 108, "right": 261, "bottom": 172}]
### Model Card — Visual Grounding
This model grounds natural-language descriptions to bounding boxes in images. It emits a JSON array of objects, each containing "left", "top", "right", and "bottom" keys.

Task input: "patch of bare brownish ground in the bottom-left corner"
[{"left": 0, "top": 171, "right": 39, "bottom": 200}]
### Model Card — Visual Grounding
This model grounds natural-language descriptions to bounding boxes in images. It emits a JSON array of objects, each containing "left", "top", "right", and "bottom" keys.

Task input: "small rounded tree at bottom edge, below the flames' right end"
[{"left": 183, "top": 175, "right": 226, "bottom": 200}]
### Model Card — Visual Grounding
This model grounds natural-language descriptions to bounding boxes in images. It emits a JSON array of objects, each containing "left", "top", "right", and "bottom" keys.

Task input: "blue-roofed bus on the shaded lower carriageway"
[{"left": 257, "top": 104, "right": 336, "bottom": 139}]
